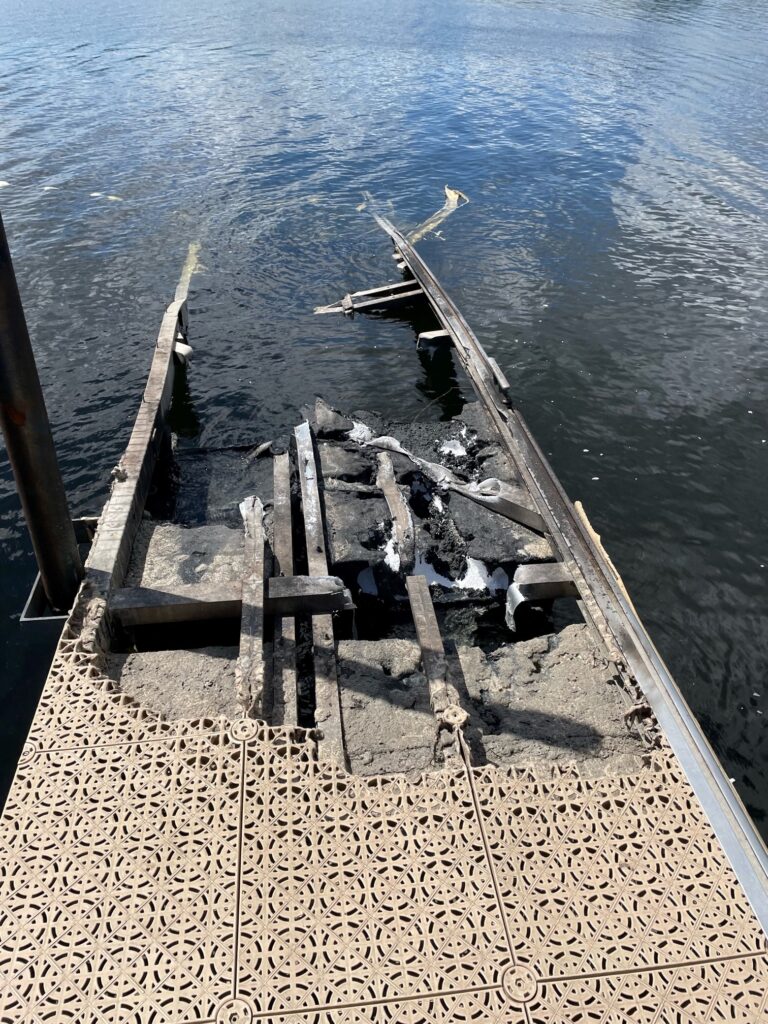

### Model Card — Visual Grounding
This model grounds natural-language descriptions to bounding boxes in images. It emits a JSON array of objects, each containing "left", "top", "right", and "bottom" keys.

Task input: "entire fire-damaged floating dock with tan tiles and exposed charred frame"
[{"left": 0, "top": 211, "right": 768, "bottom": 1024}]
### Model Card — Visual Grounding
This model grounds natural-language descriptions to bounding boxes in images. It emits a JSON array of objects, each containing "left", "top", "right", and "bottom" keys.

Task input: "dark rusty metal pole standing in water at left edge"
[{"left": 0, "top": 208, "right": 83, "bottom": 611}]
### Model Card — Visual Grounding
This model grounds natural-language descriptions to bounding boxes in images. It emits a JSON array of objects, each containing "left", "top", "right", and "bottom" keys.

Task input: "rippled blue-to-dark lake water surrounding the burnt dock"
[{"left": 0, "top": 0, "right": 768, "bottom": 833}]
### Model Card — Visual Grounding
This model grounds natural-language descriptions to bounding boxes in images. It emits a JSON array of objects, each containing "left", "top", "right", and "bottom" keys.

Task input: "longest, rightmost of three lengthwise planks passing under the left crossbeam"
[{"left": 294, "top": 422, "right": 347, "bottom": 767}]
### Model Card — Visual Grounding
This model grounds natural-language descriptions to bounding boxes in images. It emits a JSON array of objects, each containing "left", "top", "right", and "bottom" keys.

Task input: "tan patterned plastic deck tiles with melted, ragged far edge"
[{"left": 0, "top": 646, "right": 768, "bottom": 1024}]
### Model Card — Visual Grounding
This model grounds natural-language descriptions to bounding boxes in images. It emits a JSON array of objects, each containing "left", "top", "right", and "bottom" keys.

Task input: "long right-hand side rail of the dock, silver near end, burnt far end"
[{"left": 374, "top": 214, "right": 768, "bottom": 930}]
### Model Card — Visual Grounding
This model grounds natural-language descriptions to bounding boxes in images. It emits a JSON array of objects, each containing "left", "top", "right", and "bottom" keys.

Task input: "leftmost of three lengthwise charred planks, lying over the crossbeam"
[{"left": 234, "top": 496, "right": 269, "bottom": 718}]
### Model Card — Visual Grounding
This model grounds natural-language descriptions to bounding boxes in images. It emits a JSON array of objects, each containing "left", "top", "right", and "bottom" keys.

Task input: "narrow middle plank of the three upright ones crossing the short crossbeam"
[{"left": 272, "top": 452, "right": 298, "bottom": 725}]
